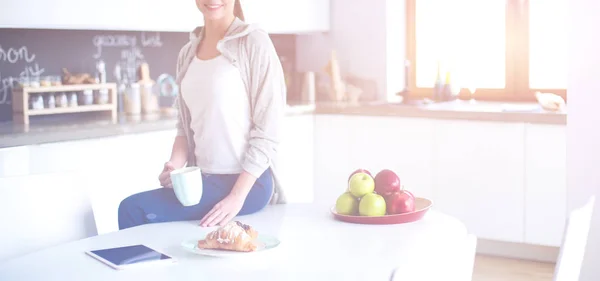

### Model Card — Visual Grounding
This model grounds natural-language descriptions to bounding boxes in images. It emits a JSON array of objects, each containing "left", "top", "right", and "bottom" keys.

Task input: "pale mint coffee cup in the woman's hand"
[{"left": 171, "top": 167, "right": 202, "bottom": 207}]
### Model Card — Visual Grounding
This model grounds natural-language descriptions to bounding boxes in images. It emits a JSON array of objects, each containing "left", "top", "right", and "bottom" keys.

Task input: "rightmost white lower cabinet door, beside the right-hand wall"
[{"left": 525, "top": 124, "right": 567, "bottom": 247}]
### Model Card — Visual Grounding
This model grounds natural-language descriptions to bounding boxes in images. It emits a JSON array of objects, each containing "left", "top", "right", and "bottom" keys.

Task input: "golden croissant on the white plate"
[{"left": 198, "top": 221, "right": 258, "bottom": 252}]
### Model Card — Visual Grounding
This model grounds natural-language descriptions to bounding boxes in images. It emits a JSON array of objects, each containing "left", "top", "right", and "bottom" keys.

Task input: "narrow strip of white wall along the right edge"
[{"left": 567, "top": 0, "right": 600, "bottom": 281}]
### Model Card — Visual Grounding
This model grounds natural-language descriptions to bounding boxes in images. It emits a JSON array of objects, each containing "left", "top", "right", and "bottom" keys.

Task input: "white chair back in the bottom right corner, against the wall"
[{"left": 553, "top": 196, "right": 596, "bottom": 281}]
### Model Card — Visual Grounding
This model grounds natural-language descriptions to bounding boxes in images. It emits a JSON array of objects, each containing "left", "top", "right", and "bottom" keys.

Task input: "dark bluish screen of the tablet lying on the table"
[{"left": 90, "top": 245, "right": 171, "bottom": 266}]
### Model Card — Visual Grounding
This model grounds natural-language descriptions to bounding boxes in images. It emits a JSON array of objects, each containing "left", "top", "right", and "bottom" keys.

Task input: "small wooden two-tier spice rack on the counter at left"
[{"left": 12, "top": 83, "right": 117, "bottom": 124}]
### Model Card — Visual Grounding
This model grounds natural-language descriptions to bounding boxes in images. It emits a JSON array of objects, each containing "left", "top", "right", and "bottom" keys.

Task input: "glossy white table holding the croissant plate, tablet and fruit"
[{"left": 0, "top": 204, "right": 467, "bottom": 281}]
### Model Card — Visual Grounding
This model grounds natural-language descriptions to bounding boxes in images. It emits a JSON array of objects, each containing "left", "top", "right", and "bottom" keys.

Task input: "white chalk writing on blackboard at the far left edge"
[{"left": 0, "top": 45, "right": 45, "bottom": 104}]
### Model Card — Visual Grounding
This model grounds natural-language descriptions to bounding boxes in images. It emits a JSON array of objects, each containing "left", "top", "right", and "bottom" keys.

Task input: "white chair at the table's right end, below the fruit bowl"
[{"left": 390, "top": 234, "right": 477, "bottom": 281}]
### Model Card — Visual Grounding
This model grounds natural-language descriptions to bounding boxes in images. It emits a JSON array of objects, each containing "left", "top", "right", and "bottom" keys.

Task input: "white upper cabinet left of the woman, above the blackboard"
[{"left": 0, "top": 0, "right": 203, "bottom": 32}]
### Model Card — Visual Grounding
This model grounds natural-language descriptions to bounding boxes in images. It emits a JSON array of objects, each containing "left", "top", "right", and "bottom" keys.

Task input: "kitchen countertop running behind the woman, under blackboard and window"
[{"left": 0, "top": 101, "right": 567, "bottom": 148}]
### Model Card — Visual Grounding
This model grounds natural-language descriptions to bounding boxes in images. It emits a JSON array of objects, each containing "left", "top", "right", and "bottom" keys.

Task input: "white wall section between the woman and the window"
[{"left": 296, "top": 0, "right": 405, "bottom": 99}]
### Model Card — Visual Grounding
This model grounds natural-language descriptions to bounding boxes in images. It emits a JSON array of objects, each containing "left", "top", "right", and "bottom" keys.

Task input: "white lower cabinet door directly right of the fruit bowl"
[{"left": 433, "top": 120, "right": 525, "bottom": 242}]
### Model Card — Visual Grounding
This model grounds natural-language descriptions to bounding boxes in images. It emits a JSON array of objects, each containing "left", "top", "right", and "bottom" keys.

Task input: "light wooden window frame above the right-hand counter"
[{"left": 405, "top": 0, "right": 567, "bottom": 102}]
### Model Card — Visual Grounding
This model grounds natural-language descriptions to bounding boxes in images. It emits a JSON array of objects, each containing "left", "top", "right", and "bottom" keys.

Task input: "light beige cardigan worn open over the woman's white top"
[{"left": 175, "top": 18, "right": 287, "bottom": 204}]
